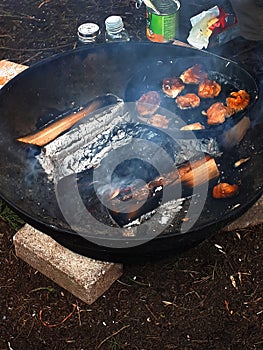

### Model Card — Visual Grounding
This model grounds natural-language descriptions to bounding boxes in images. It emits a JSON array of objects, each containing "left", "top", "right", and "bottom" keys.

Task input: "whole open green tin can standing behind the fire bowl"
[{"left": 146, "top": 0, "right": 181, "bottom": 43}]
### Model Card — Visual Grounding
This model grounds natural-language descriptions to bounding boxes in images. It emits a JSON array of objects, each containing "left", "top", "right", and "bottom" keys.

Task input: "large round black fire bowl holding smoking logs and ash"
[{"left": 0, "top": 43, "right": 262, "bottom": 261}]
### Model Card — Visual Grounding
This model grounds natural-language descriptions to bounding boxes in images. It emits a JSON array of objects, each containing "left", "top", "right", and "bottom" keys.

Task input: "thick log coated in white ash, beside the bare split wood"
[{"left": 37, "top": 102, "right": 132, "bottom": 180}]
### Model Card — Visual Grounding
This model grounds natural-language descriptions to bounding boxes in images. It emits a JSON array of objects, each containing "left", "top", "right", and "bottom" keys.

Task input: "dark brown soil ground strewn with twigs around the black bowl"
[{"left": 0, "top": 0, "right": 263, "bottom": 350}]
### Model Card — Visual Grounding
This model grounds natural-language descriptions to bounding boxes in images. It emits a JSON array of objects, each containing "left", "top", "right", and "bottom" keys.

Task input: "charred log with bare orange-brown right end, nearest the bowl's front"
[{"left": 108, "top": 155, "right": 220, "bottom": 215}]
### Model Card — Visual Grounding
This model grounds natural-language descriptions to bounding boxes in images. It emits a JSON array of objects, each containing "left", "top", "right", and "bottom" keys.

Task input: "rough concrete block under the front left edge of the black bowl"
[{"left": 13, "top": 225, "right": 123, "bottom": 304}]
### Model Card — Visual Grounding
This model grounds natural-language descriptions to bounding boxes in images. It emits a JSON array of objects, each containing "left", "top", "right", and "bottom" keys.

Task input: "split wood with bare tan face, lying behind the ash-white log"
[{"left": 17, "top": 94, "right": 118, "bottom": 146}]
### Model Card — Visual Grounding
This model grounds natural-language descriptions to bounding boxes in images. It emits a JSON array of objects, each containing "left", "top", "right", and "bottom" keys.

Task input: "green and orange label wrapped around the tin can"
[{"left": 146, "top": 1, "right": 179, "bottom": 43}]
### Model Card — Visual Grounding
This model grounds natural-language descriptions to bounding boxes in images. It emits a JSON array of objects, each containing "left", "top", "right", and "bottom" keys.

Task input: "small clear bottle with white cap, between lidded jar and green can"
[{"left": 105, "top": 16, "right": 130, "bottom": 42}]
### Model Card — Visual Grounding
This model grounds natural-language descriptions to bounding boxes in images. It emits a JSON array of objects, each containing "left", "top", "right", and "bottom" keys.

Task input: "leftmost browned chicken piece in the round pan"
[{"left": 136, "top": 91, "right": 161, "bottom": 116}]
